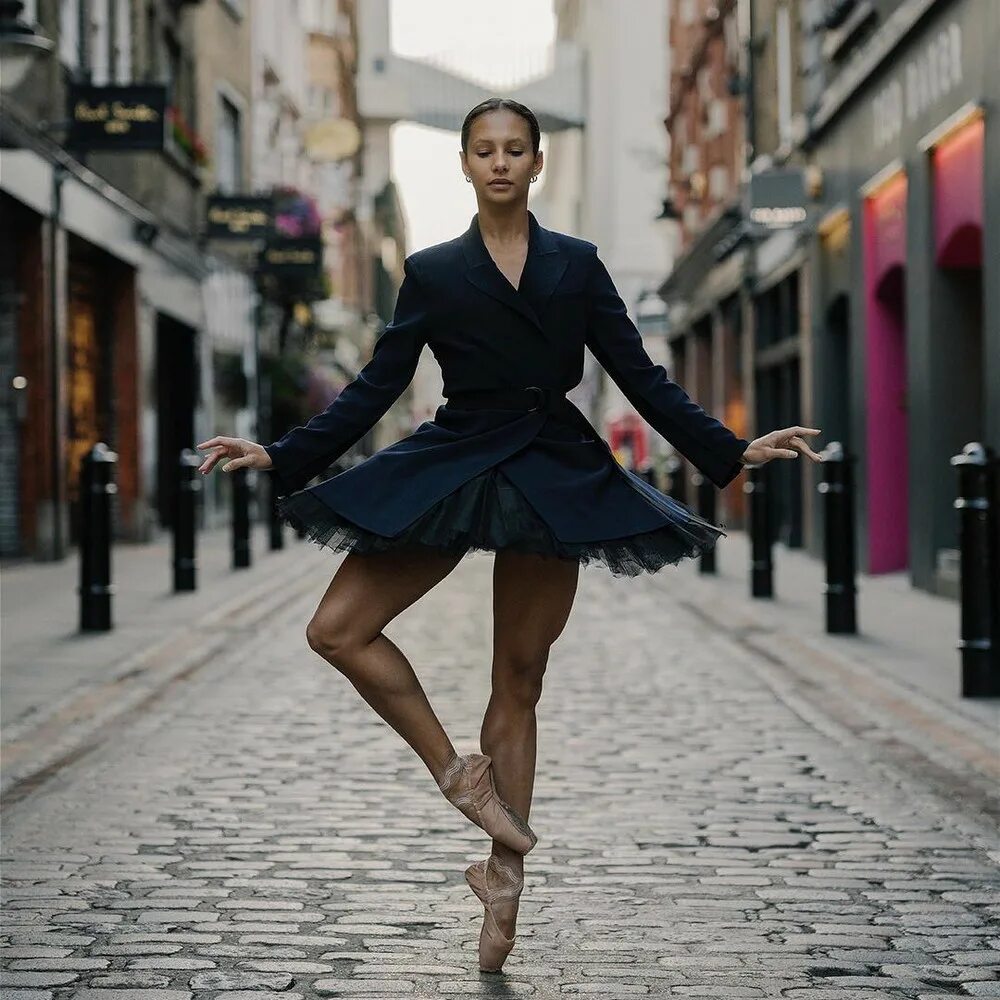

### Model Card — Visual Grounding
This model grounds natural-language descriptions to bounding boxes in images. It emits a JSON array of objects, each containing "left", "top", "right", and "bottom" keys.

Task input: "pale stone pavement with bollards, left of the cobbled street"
[{"left": 0, "top": 524, "right": 320, "bottom": 801}]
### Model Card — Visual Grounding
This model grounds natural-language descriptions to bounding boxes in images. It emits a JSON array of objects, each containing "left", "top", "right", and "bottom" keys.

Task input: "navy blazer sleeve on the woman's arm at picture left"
[{"left": 264, "top": 257, "right": 428, "bottom": 493}]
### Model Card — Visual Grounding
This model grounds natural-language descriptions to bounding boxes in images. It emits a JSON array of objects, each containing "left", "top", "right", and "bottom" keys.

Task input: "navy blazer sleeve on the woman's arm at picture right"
[{"left": 586, "top": 250, "right": 750, "bottom": 489}]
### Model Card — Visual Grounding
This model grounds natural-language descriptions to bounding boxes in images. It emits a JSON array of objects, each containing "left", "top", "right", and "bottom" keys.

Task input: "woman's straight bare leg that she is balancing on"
[{"left": 480, "top": 549, "right": 580, "bottom": 937}]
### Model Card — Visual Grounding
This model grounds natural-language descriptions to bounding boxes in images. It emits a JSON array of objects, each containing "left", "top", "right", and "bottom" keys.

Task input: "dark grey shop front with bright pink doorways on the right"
[{"left": 810, "top": 0, "right": 1000, "bottom": 595}]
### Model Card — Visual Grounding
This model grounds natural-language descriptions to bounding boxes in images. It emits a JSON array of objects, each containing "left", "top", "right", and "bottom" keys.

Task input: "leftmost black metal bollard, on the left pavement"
[{"left": 78, "top": 441, "right": 118, "bottom": 632}]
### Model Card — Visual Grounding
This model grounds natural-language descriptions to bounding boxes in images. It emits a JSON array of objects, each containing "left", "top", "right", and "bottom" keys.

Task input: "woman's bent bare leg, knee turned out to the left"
[{"left": 306, "top": 547, "right": 462, "bottom": 781}]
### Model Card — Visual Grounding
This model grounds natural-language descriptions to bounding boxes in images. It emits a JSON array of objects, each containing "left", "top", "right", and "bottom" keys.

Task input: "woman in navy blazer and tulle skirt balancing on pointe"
[{"left": 198, "top": 98, "right": 821, "bottom": 972}]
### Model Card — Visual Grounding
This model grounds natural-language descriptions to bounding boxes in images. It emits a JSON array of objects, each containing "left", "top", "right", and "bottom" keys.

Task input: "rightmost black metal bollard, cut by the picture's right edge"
[{"left": 951, "top": 441, "right": 1000, "bottom": 698}]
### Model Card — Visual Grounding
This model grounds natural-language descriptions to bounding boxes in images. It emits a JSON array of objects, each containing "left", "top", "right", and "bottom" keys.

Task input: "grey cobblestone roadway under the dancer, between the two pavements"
[{"left": 2, "top": 548, "right": 1000, "bottom": 1000}]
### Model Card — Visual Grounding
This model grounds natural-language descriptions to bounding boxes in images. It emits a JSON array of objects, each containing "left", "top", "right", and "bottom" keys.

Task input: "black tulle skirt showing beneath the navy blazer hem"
[{"left": 275, "top": 466, "right": 725, "bottom": 576}]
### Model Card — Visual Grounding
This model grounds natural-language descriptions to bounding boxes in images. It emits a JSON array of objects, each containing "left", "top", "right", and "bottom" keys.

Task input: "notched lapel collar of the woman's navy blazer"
[{"left": 460, "top": 209, "right": 569, "bottom": 334}]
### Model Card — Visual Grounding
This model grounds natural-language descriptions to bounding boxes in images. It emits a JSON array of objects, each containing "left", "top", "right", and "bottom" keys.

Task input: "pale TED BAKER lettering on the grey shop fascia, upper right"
[{"left": 872, "top": 22, "right": 962, "bottom": 148}]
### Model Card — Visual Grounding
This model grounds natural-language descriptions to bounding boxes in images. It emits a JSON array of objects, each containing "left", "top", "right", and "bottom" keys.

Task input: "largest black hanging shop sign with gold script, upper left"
[{"left": 66, "top": 83, "right": 167, "bottom": 152}]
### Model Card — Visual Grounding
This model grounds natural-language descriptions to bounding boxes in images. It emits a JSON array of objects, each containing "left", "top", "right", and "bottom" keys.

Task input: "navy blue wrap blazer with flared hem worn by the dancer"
[{"left": 265, "top": 211, "right": 749, "bottom": 541}]
